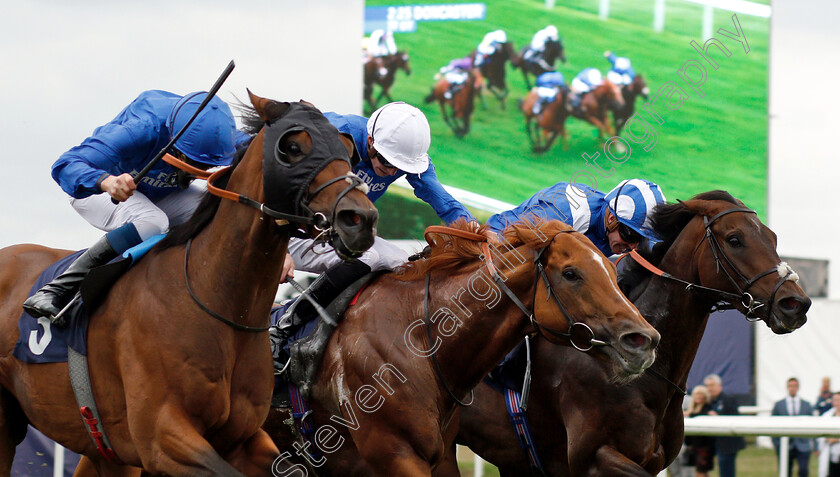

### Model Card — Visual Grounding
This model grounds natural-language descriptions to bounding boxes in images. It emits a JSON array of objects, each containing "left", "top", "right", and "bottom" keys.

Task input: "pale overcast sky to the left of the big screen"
[{"left": 0, "top": 0, "right": 363, "bottom": 249}]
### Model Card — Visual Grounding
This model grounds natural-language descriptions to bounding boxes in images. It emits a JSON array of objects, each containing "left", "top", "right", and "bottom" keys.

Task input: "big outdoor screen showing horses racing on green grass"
[{"left": 362, "top": 0, "right": 770, "bottom": 238}]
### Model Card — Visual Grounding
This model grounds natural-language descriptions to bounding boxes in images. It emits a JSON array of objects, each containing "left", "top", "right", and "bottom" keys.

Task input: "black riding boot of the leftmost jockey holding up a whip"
[{"left": 23, "top": 235, "right": 118, "bottom": 319}]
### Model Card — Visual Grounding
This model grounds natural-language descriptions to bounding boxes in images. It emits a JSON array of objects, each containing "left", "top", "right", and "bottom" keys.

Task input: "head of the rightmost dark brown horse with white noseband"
[{"left": 666, "top": 191, "right": 811, "bottom": 334}]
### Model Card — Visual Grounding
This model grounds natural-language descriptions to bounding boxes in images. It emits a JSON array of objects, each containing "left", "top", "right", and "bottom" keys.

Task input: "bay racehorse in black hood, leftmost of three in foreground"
[{"left": 0, "top": 91, "right": 377, "bottom": 477}]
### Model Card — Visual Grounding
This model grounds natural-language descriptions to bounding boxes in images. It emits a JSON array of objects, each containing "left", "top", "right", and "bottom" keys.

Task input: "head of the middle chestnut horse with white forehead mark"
[{"left": 505, "top": 221, "right": 659, "bottom": 381}]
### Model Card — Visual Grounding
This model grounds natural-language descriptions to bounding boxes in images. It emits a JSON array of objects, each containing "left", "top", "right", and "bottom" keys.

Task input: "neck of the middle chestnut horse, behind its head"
[{"left": 429, "top": 247, "right": 534, "bottom": 396}]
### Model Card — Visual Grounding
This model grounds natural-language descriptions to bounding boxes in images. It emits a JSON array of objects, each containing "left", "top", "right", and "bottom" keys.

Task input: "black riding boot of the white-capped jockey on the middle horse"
[{"left": 272, "top": 260, "right": 370, "bottom": 348}]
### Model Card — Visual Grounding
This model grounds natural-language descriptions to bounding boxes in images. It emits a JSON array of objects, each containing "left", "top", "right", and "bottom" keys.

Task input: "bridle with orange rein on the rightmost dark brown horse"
[{"left": 622, "top": 207, "right": 799, "bottom": 321}]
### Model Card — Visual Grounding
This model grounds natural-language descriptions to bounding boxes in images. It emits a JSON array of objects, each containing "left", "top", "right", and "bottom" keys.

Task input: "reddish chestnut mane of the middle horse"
[{"left": 394, "top": 219, "right": 571, "bottom": 282}]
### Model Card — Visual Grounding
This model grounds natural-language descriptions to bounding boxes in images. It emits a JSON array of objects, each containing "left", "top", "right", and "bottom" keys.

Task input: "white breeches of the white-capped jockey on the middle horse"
[{"left": 289, "top": 237, "right": 408, "bottom": 273}]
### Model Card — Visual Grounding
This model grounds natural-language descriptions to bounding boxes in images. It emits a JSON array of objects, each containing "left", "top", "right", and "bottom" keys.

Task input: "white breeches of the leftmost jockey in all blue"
[{"left": 70, "top": 181, "right": 207, "bottom": 240}]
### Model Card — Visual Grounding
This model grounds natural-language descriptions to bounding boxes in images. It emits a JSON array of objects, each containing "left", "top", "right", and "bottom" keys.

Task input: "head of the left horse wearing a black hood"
[{"left": 248, "top": 91, "right": 378, "bottom": 258}]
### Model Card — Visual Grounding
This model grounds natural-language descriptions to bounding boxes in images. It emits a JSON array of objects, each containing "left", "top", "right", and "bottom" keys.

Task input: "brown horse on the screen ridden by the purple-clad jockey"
[{"left": 425, "top": 68, "right": 483, "bottom": 138}]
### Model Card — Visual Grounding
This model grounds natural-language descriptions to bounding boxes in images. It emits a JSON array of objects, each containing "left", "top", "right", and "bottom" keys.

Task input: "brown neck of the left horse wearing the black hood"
[{"left": 188, "top": 151, "right": 289, "bottom": 326}]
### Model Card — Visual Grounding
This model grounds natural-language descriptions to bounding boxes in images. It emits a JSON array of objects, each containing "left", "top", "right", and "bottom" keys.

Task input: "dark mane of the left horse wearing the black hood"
[{"left": 152, "top": 101, "right": 294, "bottom": 252}]
